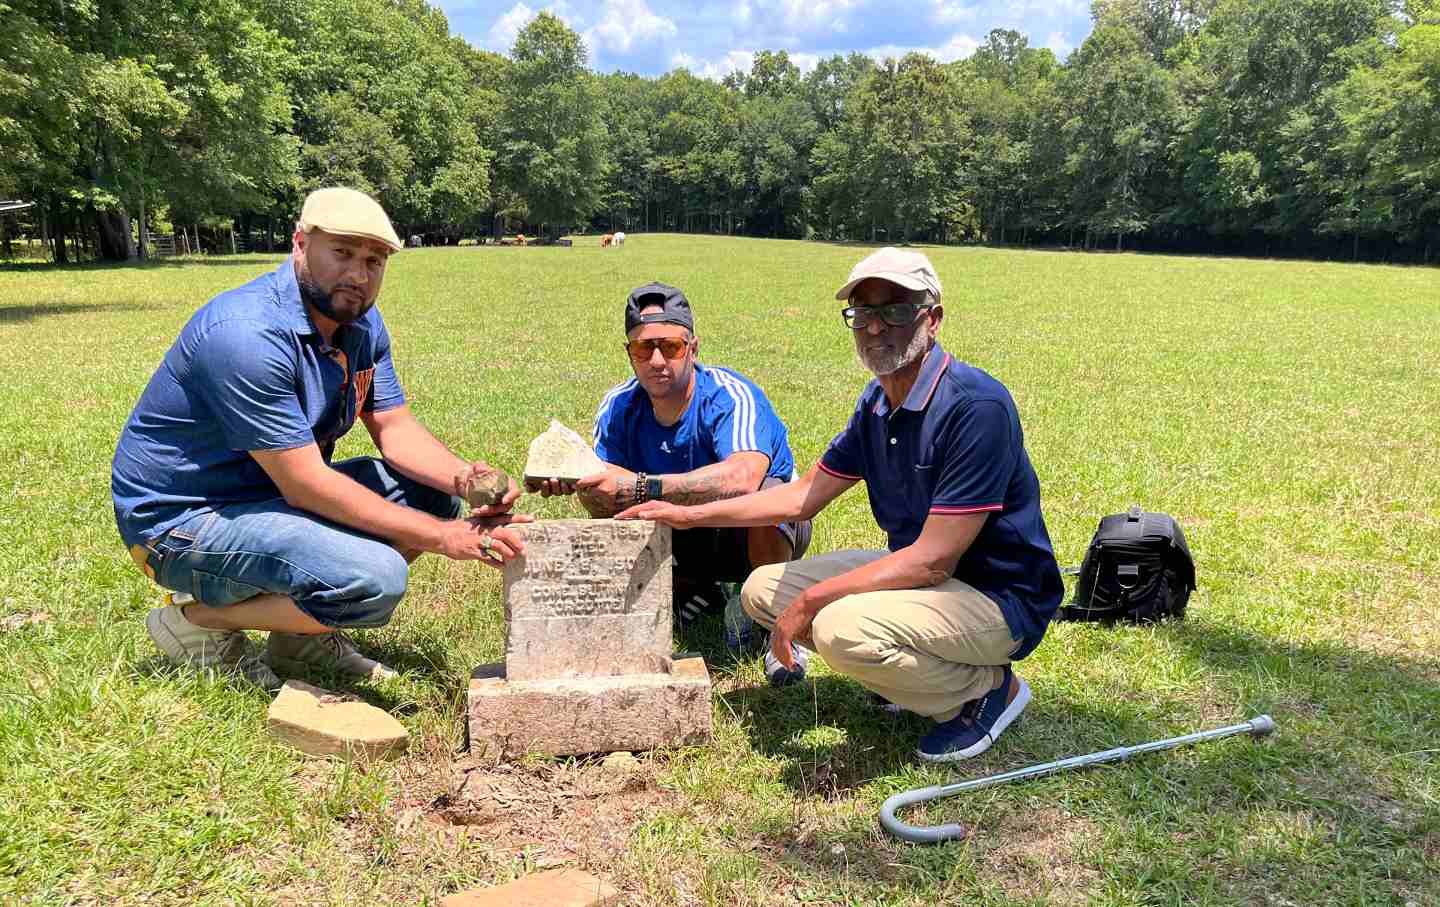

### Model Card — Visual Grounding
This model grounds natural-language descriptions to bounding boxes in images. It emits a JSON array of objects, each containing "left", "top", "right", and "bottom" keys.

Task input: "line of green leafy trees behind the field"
[{"left": 0, "top": 0, "right": 1440, "bottom": 262}]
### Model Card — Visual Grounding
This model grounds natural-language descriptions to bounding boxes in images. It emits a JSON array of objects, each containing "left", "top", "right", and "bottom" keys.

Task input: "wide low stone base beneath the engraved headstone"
[{"left": 467, "top": 656, "right": 710, "bottom": 760}]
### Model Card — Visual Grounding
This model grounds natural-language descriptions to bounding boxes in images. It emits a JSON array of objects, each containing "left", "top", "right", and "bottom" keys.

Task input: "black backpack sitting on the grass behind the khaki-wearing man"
[{"left": 1060, "top": 505, "right": 1195, "bottom": 623}]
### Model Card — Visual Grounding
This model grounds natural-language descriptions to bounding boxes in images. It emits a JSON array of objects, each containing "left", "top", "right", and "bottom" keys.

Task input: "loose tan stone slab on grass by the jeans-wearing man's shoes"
[{"left": 266, "top": 680, "right": 410, "bottom": 759}]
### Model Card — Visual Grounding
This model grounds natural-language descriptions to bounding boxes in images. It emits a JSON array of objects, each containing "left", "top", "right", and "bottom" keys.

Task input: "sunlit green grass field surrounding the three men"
[{"left": 0, "top": 236, "right": 1440, "bottom": 907}]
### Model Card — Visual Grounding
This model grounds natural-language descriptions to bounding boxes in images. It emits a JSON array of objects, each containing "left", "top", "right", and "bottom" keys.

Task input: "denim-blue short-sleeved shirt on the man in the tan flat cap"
[{"left": 111, "top": 259, "right": 405, "bottom": 546}]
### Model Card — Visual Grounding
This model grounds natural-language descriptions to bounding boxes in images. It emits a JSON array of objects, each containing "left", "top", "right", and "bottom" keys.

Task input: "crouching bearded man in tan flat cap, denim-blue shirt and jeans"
[{"left": 111, "top": 187, "right": 524, "bottom": 688}]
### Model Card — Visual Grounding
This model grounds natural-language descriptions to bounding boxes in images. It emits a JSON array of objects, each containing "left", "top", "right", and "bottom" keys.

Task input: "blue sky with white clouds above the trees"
[{"left": 431, "top": 0, "right": 1090, "bottom": 78}]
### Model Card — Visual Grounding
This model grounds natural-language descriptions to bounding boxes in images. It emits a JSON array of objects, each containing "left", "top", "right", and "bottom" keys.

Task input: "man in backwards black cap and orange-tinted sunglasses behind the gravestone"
[{"left": 539, "top": 284, "right": 811, "bottom": 646}]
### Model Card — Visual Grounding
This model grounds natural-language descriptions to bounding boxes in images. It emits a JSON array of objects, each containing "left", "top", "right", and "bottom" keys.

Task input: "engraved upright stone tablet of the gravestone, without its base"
[{"left": 504, "top": 520, "right": 672, "bottom": 681}]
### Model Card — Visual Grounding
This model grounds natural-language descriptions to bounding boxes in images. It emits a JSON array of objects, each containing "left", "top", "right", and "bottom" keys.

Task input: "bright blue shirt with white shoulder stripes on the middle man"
[{"left": 595, "top": 363, "right": 795, "bottom": 482}]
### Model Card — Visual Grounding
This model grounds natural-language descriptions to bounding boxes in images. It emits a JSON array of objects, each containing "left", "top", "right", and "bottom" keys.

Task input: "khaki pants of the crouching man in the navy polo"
[{"left": 740, "top": 551, "right": 1020, "bottom": 721}]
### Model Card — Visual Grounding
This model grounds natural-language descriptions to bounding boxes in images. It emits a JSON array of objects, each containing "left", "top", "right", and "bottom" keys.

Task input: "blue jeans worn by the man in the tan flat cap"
[{"left": 135, "top": 456, "right": 464, "bottom": 628}]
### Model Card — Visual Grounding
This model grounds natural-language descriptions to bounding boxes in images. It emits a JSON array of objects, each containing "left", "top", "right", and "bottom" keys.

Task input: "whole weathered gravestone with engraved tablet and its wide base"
[{"left": 468, "top": 520, "right": 710, "bottom": 759}]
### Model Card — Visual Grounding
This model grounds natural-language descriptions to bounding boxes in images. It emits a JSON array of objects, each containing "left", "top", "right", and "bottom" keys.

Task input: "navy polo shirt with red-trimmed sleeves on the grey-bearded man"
[{"left": 819, "top": 344, "right": 1064, "bottom": 659}]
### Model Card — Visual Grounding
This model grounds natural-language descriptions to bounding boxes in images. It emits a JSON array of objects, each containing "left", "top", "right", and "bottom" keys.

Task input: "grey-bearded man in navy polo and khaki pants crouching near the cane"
[{"left": 619, "top": 249, "right": 1061, "bottom": 762}]
